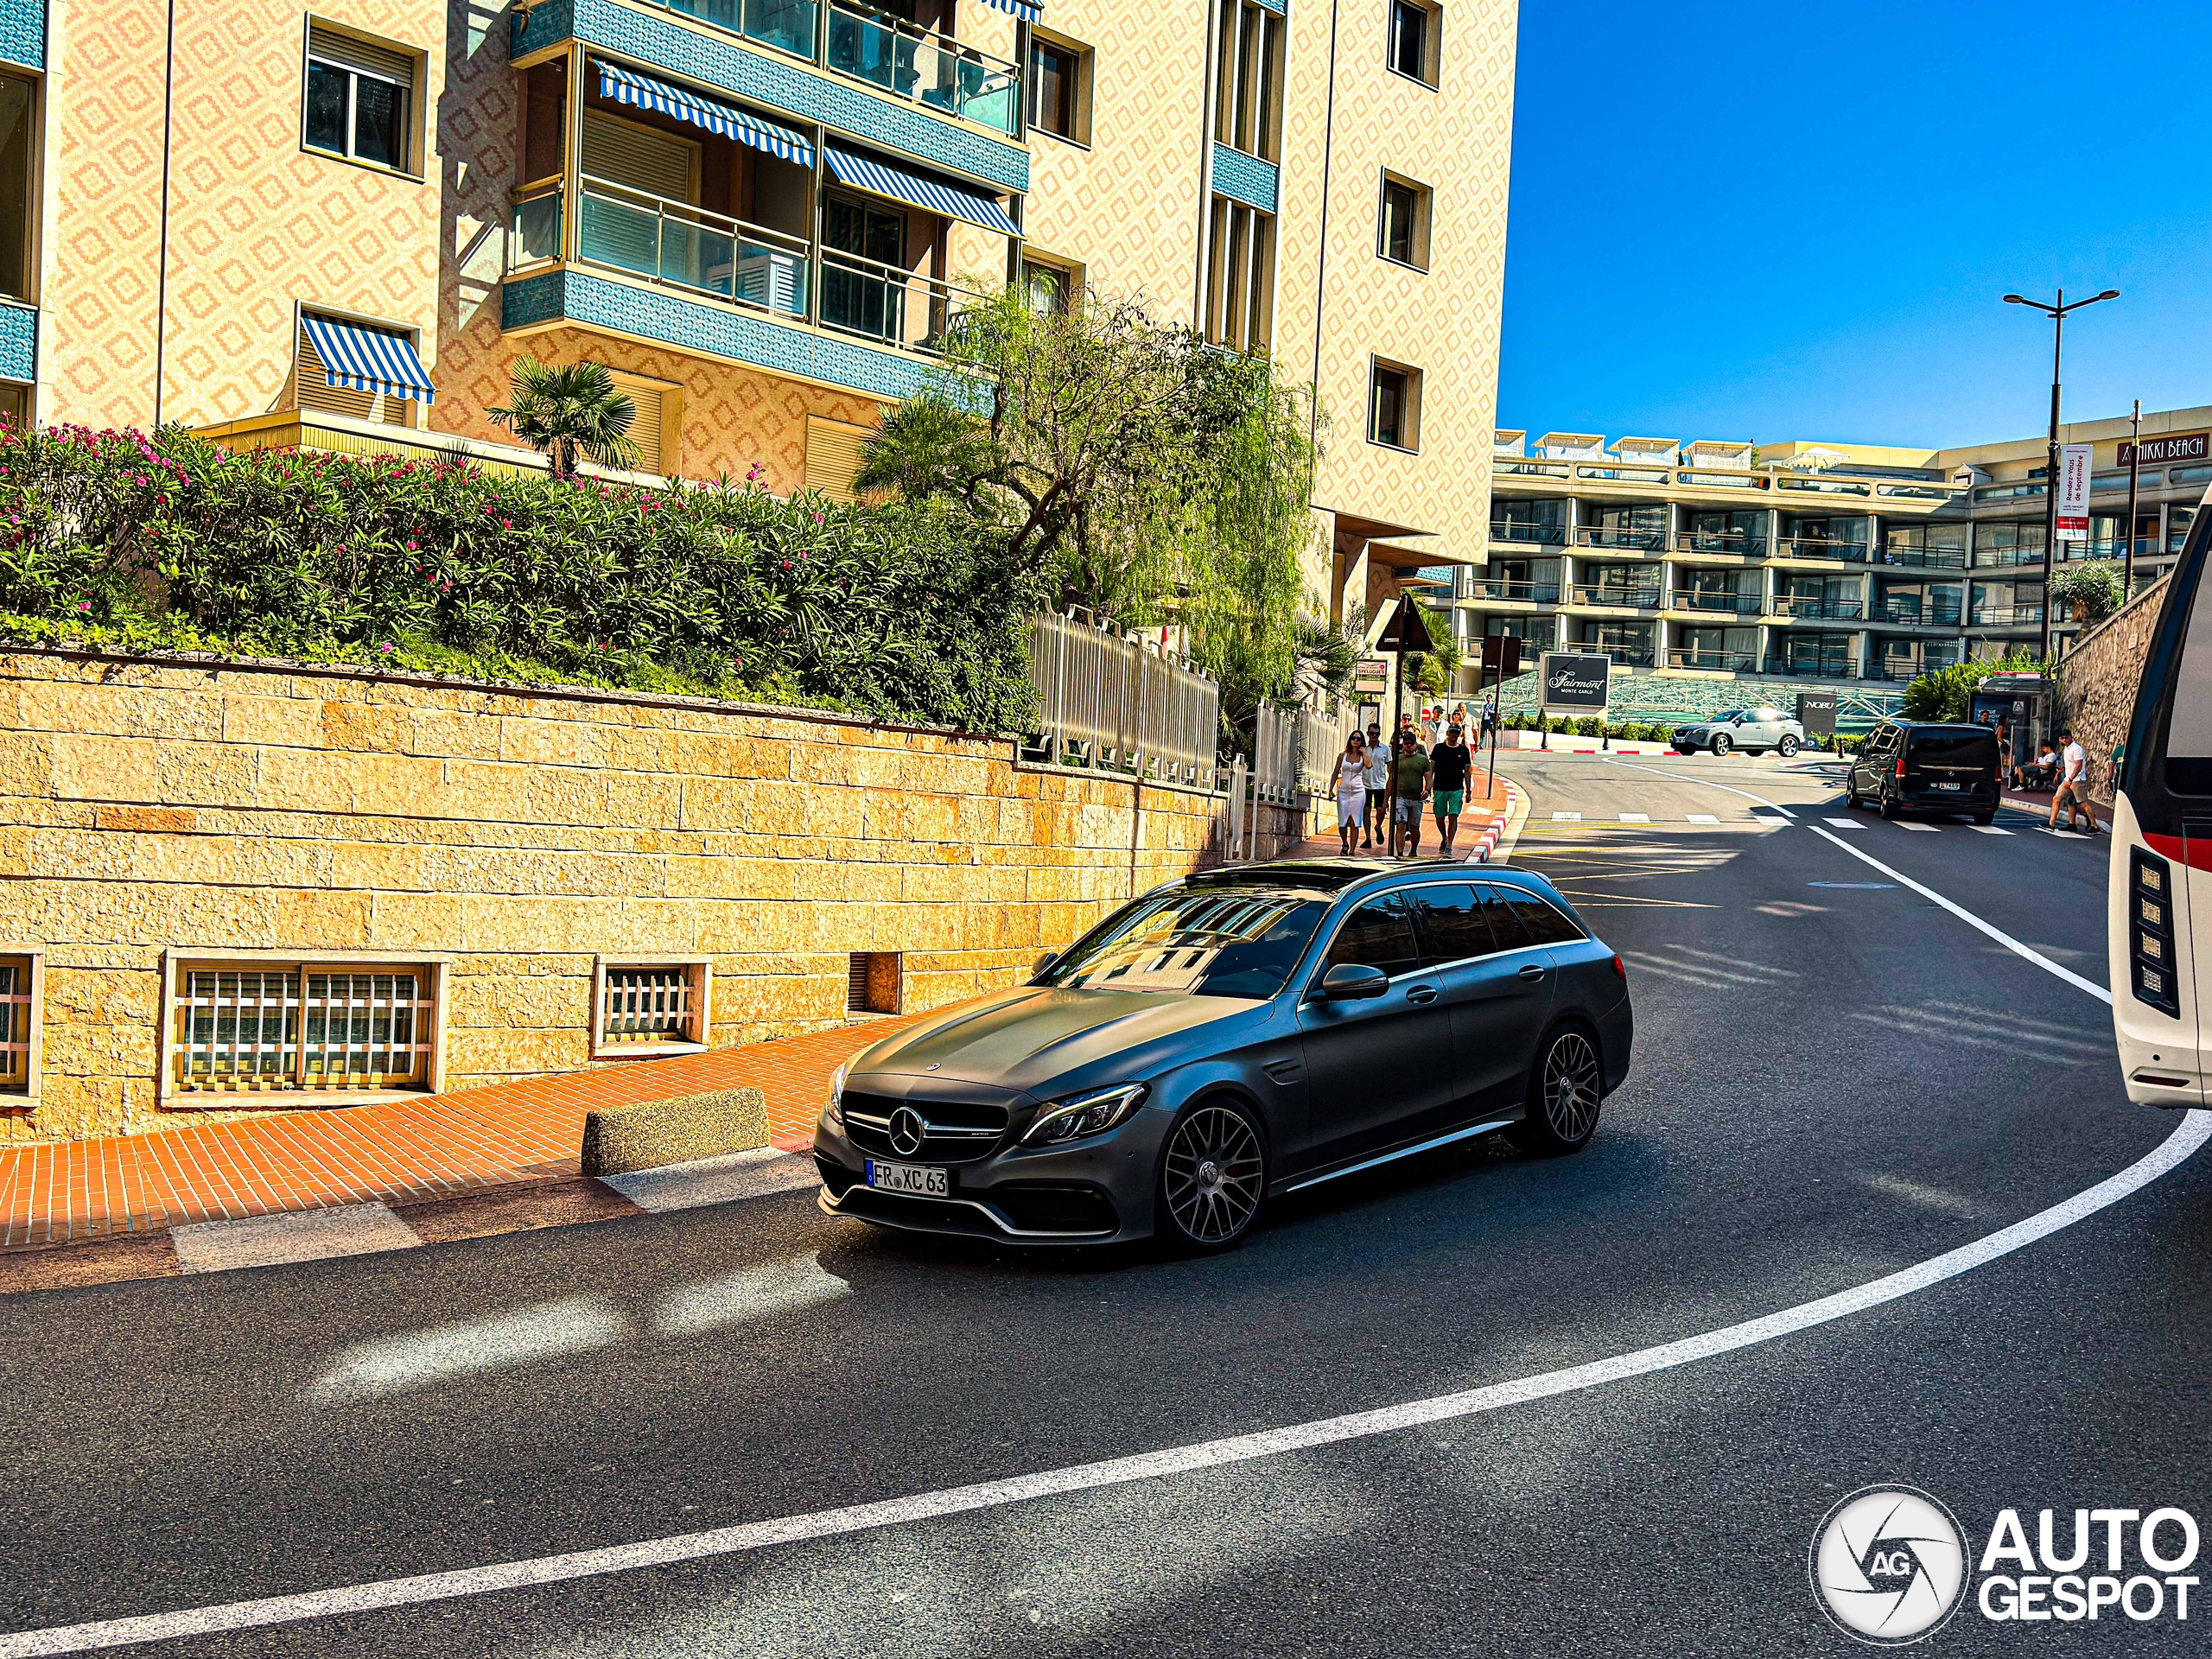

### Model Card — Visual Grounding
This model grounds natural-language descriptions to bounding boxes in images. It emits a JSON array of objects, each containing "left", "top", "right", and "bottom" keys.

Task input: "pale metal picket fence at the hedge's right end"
[{"left": 1028, "top": 611, "right": 1221, "bottom": 790}]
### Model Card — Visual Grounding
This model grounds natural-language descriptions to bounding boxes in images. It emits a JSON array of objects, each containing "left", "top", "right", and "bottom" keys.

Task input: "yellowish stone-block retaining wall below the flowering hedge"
[{"left": 0, "top": 652, "right": 1265, "bottom": 1141}]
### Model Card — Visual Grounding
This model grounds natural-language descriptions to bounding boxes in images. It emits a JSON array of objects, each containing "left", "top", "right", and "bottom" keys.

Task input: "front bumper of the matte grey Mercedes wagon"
[{"left": 814, "top": 1109, "right": 1170, "bottom": 1245}]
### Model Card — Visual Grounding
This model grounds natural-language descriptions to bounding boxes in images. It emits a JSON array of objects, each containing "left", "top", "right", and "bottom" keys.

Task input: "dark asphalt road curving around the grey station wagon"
[{"left": 0, "top": 757, "right": 2212, "bottom": 1659}]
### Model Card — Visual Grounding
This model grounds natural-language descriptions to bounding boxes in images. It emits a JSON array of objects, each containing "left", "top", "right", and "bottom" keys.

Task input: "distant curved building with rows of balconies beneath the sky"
[{"left": 1455, "top": 407, "right": 2212, "bottom": 706}]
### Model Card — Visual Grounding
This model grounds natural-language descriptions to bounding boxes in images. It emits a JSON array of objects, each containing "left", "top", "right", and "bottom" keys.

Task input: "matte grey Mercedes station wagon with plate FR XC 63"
[{"left": 814, "top": 858, "right": 1635, "bottom": 1249}]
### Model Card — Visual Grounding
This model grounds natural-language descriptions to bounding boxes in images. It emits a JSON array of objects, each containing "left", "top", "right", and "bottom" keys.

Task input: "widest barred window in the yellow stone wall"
[{"left": 170, "top": 963, "right": 438, "bottom": 1095}]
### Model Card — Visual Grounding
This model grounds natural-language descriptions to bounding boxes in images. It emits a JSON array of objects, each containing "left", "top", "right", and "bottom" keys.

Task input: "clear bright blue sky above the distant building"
[{"left": 1497, "top": 0, "right": 2212, "bottom": 447}]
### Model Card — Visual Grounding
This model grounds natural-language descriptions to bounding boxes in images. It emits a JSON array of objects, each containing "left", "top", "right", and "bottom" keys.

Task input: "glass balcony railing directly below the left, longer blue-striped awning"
[{"left": 570, "top": 179, "right": 814, "bottom": 319}]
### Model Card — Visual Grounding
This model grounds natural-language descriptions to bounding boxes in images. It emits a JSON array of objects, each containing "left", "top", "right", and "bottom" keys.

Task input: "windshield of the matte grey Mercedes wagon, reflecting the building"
[{"left": 1039, "top": 887, "right": 1330, "bottom": 1000}]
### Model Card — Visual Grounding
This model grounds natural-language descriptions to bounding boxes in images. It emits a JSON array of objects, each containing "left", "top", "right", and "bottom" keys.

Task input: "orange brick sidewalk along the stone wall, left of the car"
[{"left": 0, "top": 1013, "right": 923, "bottom": 1249}]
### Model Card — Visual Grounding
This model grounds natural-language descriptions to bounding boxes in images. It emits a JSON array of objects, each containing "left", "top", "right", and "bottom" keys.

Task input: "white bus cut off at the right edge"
[{"left": 2106, "top": 491, "right": 2212, "bottom": 1106}]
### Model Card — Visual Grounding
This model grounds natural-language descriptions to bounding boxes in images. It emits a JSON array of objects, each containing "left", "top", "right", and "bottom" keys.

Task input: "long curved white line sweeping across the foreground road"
[{"left": 21, "top": 1110, "right": 2212, "bottom": 1659}]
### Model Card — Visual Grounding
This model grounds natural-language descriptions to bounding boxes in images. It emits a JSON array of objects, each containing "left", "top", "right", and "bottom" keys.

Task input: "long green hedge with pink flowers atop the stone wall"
[{"left": 0, "top": 427, "right": 1038, "bottom": 732}]
